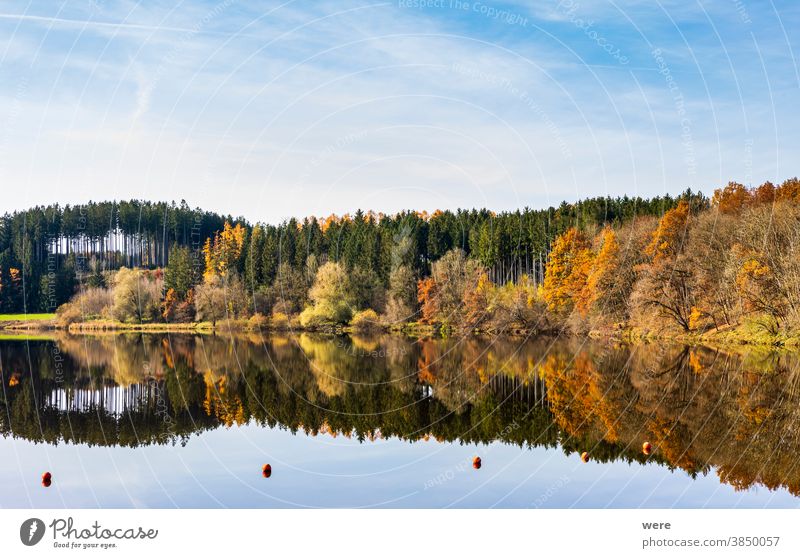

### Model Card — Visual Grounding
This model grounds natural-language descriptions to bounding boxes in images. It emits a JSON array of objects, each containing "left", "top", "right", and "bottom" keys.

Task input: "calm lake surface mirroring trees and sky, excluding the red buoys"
[{"left": 0, "top": 333, "right": 800, "bottom": 508}]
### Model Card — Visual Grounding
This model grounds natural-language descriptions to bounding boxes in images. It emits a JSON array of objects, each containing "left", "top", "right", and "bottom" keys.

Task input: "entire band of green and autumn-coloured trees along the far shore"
[{"left": 0, "top": 178, "right": 800, "bottom": 342}]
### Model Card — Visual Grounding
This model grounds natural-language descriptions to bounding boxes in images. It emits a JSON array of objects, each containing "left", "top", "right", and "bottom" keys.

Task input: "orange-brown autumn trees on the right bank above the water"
[{"left": 538, "top": 179, "right": 800, "bottom": 342}]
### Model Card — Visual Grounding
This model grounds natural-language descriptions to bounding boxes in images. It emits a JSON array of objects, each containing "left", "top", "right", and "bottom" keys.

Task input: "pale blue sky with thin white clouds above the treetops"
[{"left": 0, "top": 0, "right": 800, "bottom": 222}]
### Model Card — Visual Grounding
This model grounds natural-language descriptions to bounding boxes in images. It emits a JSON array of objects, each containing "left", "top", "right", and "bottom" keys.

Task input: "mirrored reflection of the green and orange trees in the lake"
[{"left": 0, "top": 334, "right": 800, "bottom": 495}]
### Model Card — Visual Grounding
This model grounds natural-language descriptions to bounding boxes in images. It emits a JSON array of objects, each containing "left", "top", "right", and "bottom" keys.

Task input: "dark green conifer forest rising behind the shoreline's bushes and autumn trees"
[{"left": 0, "top": 191, "right": 706, "bottom": 313}]
